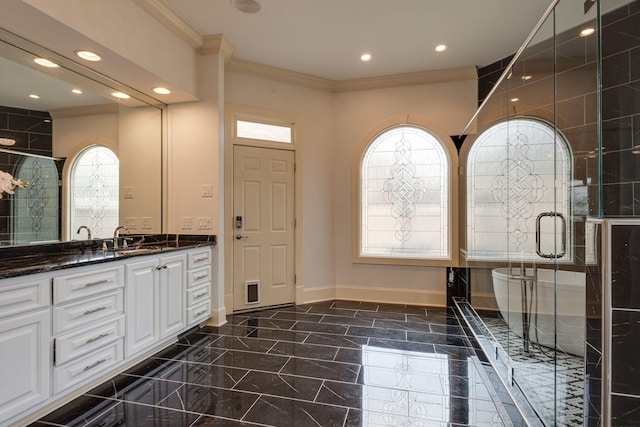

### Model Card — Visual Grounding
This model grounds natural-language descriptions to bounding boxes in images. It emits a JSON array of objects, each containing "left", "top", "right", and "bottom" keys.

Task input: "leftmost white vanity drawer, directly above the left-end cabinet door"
[{"left": 0, "top": 278, "right": 51, "bottom": 318}]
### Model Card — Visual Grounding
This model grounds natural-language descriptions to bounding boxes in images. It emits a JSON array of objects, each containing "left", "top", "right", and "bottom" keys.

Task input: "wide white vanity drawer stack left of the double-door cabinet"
[{"left": 53, "top": 263, "right": 125, "bottom": 394}]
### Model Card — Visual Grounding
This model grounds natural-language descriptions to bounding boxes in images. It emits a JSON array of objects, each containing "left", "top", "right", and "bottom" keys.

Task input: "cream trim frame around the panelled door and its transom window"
[{"left": 224, "top": 104, "right": 304, "bottom": 314}]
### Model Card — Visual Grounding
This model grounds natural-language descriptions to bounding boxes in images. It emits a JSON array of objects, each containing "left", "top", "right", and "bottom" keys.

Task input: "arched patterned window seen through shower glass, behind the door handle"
[{"left": 467, "top": 117, "right": 572, "bottom": 261}]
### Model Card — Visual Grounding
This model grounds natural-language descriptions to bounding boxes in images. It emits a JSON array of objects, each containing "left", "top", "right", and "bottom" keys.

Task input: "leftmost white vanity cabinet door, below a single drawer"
[{"left": 0, "top": 309, "right": 51, "bottom": 424}]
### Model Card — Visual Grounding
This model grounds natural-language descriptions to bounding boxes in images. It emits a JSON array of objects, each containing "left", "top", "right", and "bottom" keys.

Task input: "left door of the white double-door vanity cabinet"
[{"left": 125, "top": 258, "right": 160, "bottom": 357}]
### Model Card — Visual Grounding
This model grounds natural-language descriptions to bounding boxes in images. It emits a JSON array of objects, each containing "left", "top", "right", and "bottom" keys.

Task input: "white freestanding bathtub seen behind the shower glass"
[{"left": 492, "top": 268, "right": 585, "bottom": 356}]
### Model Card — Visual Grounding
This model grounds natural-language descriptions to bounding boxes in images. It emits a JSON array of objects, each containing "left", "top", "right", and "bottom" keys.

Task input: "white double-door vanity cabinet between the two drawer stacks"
[{"left": 125, "top": 253, "right": 187, "bottom": 357}]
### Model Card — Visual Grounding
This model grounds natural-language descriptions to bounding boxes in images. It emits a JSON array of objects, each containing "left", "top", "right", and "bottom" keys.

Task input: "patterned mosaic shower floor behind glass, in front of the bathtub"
[{"left": 481, "top": 313, "right": 584, "bottom": 427}]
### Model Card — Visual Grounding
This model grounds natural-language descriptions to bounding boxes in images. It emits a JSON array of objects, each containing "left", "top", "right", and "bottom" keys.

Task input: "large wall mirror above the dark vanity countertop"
[{"left": 0, "top": 29, "right": 165, "bottom": 246}]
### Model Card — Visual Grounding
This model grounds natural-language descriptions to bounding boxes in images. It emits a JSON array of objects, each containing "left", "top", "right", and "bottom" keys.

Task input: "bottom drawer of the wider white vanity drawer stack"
[{"left": 53, "top": 339, "right": 124, "bottom": 394}]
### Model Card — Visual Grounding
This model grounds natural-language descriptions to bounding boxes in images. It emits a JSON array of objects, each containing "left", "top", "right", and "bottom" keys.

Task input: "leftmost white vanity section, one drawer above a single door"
[{"left": 0, "top": 275, "right": 51, "bottom": 424}]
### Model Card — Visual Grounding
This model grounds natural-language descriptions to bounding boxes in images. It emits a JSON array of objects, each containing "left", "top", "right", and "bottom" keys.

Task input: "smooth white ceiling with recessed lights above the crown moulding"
[{"left": 165, "top": 0, "right": 556, "bottom": 80}]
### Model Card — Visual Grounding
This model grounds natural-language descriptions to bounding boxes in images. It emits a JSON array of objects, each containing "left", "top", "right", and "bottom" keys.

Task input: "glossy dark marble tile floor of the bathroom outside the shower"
[{"left": 32, "top": 301, "right": 525, "bottom": 427}]
